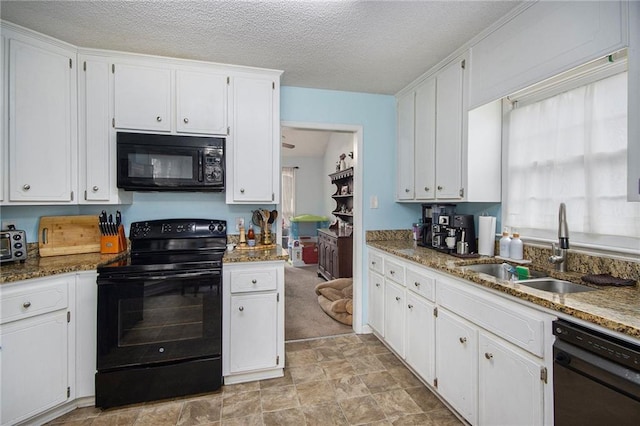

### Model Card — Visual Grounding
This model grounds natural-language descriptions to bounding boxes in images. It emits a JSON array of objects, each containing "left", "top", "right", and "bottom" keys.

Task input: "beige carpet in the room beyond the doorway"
[{"left": 284, "top": 265, "right": 353, "bottom": 341}]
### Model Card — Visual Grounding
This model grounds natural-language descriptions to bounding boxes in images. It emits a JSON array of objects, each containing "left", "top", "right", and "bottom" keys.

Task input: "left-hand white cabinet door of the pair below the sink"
[{"left": 436, "top": 309, "right": 478, "bottom": 424}]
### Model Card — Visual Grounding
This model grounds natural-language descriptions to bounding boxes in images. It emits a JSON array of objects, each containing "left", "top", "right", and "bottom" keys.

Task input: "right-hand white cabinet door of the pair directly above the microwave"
[{"left": 176, "top": 70, "right": 228, "bottom": 135}]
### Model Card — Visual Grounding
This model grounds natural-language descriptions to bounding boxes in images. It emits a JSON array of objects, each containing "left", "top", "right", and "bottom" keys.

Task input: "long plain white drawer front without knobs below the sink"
[{"left": 437, "top": 281, "right": 545, "bottom": 357}]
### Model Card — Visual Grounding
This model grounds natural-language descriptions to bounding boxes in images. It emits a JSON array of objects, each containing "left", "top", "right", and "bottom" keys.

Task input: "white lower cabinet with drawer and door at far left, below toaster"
[{"left": 0, "top": 275, "right": 74, "bottom": 425}]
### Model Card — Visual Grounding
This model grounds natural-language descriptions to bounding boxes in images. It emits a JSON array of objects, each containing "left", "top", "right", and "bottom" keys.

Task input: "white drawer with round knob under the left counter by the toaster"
[{"left": 0, "top": 278, "right": 69, "bottom": 324}]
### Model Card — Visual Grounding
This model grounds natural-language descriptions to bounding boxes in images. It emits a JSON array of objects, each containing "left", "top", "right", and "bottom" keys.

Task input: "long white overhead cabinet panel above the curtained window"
[{"left": 469, "top": 1, "right": 634, "bottom": 108}]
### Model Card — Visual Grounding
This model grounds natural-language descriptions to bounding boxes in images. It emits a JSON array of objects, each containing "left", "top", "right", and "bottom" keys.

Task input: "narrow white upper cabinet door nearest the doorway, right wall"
[{"left": 396, "top": 91, "right": 415, "bottom": 200}]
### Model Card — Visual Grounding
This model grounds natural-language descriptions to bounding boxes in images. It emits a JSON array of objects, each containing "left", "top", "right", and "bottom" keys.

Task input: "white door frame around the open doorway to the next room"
[{"left": 280, "top": 121, "right": 368, "bottom": 334}]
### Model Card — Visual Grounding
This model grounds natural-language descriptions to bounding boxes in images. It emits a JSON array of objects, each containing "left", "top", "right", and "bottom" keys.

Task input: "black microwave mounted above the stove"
[{"left": 116, "top": 132, "right": 225, "bottom": 192}]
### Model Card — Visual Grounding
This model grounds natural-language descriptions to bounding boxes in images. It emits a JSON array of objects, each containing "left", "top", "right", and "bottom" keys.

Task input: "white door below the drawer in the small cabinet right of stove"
[{"left": 229, "top": 293, "right": 278, "bottom": 373}]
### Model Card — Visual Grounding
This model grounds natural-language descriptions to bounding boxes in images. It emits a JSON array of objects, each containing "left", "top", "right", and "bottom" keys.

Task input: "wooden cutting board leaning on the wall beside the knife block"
[{"left": 38, "top": 215, "right": 100, "bottom": 257}]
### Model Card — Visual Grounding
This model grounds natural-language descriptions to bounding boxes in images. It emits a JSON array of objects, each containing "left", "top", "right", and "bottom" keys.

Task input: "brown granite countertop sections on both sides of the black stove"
[{"left": 0, "top": 246, "right": 289, "bottom": 284}]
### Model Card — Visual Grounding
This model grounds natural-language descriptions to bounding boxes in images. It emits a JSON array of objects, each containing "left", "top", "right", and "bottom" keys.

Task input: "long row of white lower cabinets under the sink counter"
[{"left": 368, "top": 247, "right": 555, "bottom": 426}]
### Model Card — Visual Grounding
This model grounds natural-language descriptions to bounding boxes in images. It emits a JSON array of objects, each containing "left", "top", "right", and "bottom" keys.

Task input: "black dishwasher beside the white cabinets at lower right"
[{"left": 553, "top": 320, "right": 640, "bottom": 426}]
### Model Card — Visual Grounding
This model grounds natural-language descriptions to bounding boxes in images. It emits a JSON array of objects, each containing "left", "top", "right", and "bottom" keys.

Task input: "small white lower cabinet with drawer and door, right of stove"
[{"left": 222, "top": 261, "right": 284, "bottom": 384}]
